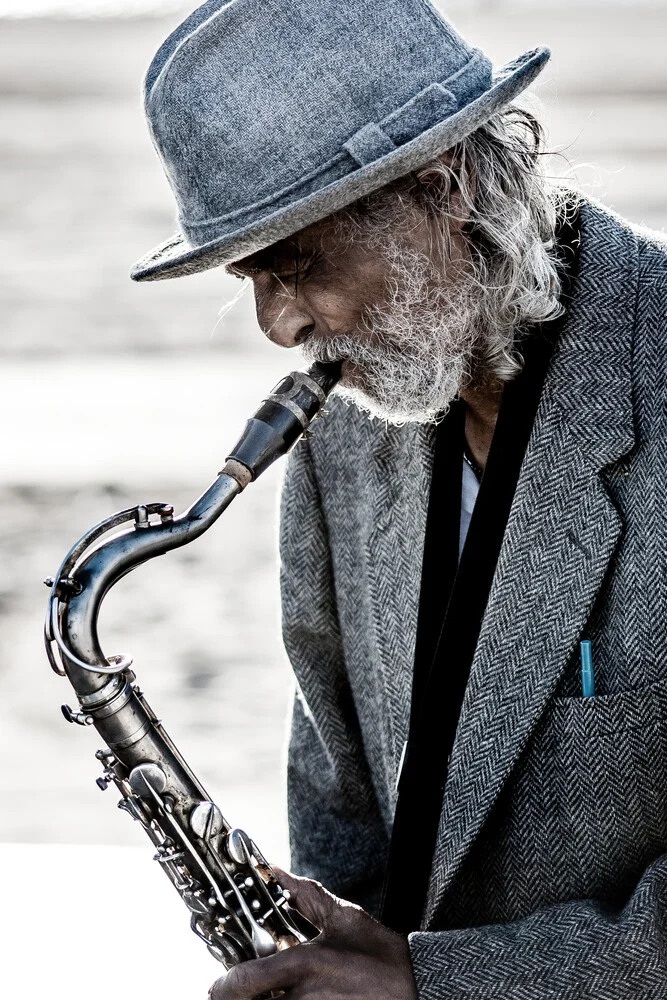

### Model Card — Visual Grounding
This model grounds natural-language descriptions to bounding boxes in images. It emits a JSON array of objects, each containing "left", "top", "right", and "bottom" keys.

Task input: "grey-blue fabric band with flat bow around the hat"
[{"left": 179, "top": 49, "right": 493, "bottom": 246}]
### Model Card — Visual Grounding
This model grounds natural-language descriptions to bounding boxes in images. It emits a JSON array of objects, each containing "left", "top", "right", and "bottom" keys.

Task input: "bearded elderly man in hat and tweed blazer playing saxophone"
[{"left": 133, "top": 0, "right": 667, "bottom": 1000}]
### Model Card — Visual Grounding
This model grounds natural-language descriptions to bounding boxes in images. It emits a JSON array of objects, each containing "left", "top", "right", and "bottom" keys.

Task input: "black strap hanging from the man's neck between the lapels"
[{"left": 381, "top": 207, "right": 578, "bottom": 933}]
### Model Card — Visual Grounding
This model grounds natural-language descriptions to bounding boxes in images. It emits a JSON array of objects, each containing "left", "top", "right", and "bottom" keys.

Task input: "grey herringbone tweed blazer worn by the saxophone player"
[{"left": 281, "top": 201, "right": 667, "bottom": 1000}]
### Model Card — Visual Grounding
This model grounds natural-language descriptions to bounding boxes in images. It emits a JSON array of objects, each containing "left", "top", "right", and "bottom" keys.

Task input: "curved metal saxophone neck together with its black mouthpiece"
[{"left": 45, "top": 362, "right": 341, "bottom": 696}]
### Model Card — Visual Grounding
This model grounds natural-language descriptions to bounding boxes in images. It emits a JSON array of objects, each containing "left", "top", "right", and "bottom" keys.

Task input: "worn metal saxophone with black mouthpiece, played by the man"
[{"left": 45, "top": 363, "right": 340, "bottom": 969}]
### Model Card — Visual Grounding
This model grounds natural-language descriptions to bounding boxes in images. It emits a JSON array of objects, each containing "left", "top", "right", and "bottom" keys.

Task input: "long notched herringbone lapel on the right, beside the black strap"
[{"left": 425, "top": 202, "right": 637, "bottom": 927}]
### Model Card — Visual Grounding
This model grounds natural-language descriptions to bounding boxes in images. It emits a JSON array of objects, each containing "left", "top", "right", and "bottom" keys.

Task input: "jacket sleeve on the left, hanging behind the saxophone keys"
[{"left": 280, "top": 442, "right": 388, "bottom": 912}]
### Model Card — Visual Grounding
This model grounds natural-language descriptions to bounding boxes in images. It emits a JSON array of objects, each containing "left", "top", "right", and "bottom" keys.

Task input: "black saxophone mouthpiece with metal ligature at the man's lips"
[{"left": 223, "top": 361, "right": 342, "bottom": 487}]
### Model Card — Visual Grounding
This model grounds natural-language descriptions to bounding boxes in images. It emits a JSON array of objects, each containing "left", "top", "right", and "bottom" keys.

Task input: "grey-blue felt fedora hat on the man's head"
[{"left": 132, "top": 0, "right": 549, "bottom": 281}]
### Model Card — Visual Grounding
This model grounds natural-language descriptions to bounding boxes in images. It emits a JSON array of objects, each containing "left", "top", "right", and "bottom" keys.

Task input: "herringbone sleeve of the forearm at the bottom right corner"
[{"left": 409, "top": 855, "right": 667, "bottom": 1000}]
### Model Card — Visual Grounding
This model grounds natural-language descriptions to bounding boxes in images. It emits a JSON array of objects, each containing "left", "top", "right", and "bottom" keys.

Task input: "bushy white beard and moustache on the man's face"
[{"left": 301, "top": 242, "right": 479, "bottom": 424}]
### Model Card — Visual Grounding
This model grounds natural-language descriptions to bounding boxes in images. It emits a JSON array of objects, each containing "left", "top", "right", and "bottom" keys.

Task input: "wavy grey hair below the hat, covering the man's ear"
[{"left": 339, "top": 106, "right": 565, "bottom": 382}]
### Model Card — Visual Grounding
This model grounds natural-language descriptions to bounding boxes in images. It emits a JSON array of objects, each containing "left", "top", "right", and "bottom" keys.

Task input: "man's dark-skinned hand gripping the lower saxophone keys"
[{"left": 209, "top": 871, "right": 417, "bottom": 1000}]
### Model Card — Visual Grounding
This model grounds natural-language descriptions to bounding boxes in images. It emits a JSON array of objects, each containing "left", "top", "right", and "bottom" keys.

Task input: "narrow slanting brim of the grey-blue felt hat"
[{"left": 130, "top": 47, "right": 551, "bottom": 281}]
